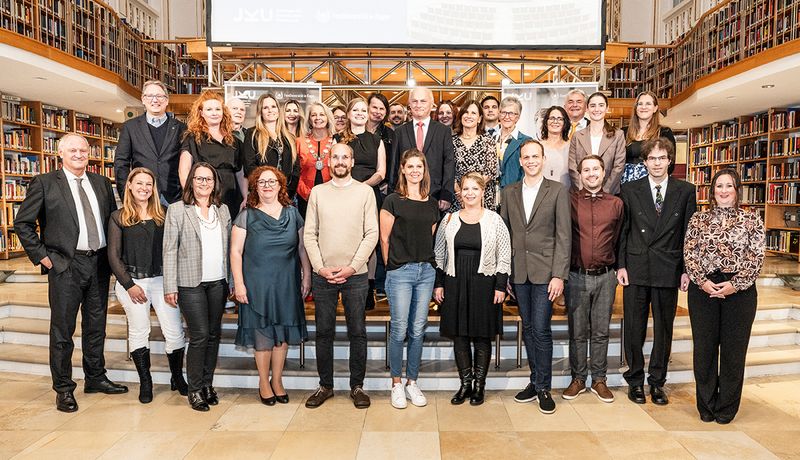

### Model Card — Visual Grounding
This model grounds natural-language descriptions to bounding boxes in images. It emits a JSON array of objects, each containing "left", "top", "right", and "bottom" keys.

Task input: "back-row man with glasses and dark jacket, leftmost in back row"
[{"left": 114, "top": 80, "right": 186, "bottom": 205}]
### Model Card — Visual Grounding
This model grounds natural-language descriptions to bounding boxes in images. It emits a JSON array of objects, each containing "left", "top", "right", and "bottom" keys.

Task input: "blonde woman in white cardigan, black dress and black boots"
[{"left": 434, "top": 172, "right": 511, "bottom": 406}]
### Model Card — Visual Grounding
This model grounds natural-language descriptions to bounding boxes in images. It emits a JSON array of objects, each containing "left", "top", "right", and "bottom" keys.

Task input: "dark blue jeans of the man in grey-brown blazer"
[{"left": 514, "top": 282, "right": 553, "bottom": 391}]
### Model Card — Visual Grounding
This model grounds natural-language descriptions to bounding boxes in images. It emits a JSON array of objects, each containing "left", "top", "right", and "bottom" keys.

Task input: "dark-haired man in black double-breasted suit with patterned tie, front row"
[{"left": 617, "top": 137, "right": 696, "bottom": 405}]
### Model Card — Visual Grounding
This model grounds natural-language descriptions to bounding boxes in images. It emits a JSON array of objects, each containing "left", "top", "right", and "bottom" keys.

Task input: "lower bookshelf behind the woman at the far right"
[{"left": 688, "top": 107, "right": 800, "bottom": 259}]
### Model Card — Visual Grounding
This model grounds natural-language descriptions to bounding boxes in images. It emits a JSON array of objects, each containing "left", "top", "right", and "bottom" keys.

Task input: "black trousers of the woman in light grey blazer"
[{"left": 178, "top": 280, "right": 228, "bottom": 391}]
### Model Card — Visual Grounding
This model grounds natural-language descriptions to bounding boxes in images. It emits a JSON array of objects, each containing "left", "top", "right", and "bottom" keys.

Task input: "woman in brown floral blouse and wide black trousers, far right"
[{"left": 684, "top": 169, "right": 765, "bottom": 424}]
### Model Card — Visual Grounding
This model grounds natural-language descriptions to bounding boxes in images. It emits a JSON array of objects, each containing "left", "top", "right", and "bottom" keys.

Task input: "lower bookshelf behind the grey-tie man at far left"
[{"left": 0, "top": 90, "right": 122, "bottom": 259}]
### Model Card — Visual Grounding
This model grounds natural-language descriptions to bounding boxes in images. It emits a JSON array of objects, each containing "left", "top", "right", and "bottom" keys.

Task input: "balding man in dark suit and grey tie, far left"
[{"left": 14, "top": 134, "right": 128, "bottom": 412}]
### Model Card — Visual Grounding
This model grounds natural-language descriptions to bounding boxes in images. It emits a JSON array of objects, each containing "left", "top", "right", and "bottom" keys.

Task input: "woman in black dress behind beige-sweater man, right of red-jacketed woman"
[{"left": 335, "top": 98, "right": 386, "bottom": 310}]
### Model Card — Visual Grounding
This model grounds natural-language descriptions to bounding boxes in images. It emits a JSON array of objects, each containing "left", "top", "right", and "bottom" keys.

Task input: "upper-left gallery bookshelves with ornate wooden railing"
[{"left": 0, "top": 0, "right": 206, "bottom": 94}]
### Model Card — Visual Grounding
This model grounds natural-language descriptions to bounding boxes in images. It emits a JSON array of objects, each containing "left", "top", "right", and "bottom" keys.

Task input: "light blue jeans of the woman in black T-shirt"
[{"left": 386, "top": 262, "right": 436, "bottom": 380}]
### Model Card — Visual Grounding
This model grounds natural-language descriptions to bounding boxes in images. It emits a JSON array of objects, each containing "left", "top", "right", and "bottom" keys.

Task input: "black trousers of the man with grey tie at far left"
[{"left": 47, "top": 249, "right": 111, "bottom": 392}]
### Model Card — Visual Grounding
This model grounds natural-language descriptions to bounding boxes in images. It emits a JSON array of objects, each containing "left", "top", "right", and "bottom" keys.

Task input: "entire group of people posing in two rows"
[{"left": 15, "top": 81, "right": 764, "bottom": 423}]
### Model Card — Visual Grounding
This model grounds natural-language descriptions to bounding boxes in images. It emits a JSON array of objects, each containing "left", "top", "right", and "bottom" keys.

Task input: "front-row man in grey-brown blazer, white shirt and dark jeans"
[{"left": 500, "top": 139, "right": 572, "bottom": 414}]
